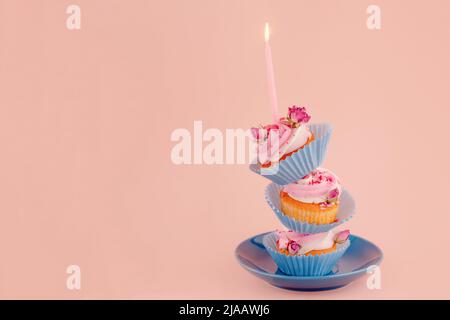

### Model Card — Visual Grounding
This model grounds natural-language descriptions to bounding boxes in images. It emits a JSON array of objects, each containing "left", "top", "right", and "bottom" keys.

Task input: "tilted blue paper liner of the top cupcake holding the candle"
[{"left": 250, "top": 123, "right": 333, "bottom": 185}]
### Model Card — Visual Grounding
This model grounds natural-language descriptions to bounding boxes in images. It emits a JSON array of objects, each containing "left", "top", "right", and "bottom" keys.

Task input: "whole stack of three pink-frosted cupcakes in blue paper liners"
[{"left": 250, "top": 106, "right": 355, "bottom": 276}]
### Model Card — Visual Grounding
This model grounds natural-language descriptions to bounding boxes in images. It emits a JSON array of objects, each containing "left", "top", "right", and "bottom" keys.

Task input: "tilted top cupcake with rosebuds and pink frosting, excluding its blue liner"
[{"left": 251, "top": 106, "right": 314, "bottom": 168}]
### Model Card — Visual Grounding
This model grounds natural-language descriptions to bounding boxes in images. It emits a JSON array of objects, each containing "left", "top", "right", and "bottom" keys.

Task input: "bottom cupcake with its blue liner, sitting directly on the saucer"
[{"left": 263, "top": 229, "right": 350, "bottom": 277}]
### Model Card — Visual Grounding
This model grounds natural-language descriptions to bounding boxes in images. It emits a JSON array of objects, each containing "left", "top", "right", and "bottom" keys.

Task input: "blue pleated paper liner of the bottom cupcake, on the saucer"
[{"left": 263, "top": 232, "right": 350, "bottom": 277}]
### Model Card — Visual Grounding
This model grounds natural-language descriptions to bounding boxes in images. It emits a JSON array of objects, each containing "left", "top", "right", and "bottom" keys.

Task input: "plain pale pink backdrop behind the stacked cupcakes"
[{"left": 0, "top": 0, "right": 450, "bottom": 299}]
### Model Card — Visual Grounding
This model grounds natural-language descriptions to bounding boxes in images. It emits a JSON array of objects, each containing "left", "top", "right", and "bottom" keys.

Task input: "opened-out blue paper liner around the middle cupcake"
[{"left": 265, "top": 183, "right": 356, "bottom": 233}]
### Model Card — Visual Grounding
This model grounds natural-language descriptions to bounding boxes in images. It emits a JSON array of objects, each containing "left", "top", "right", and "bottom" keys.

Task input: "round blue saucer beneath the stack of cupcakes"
[{"left": 235, "top": 233, "right": 383, "bottom": 291}]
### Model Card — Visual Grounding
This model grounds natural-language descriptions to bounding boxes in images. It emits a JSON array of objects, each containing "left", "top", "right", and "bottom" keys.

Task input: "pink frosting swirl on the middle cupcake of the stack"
[{"left": 283, "top": 168, "right": 341, "bottom": 203}]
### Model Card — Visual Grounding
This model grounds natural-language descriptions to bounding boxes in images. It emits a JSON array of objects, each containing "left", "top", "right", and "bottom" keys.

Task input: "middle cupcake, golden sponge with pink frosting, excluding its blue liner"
[{"left": 280, "top": 168, "right": 342, "bottom": 224}]
